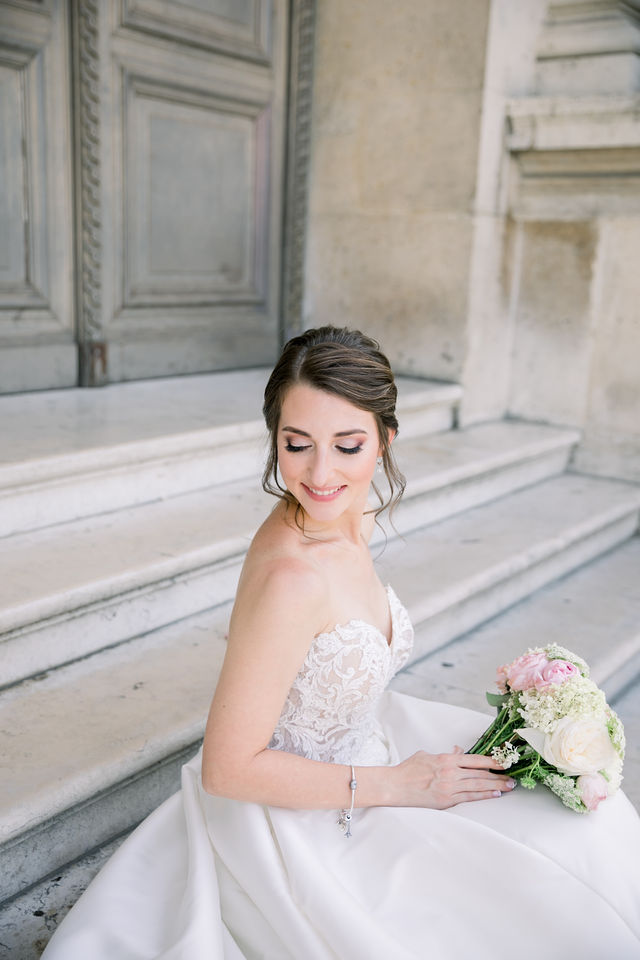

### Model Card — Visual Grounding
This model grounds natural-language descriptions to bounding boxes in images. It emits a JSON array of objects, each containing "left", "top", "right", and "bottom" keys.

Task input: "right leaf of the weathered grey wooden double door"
[{"left": 80, "top": 0, "right": 287, "bottom": 383}]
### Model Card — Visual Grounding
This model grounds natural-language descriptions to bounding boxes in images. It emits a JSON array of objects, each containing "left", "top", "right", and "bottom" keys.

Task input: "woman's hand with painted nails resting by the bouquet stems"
[{"left": 390, "top": 747, "right": 515, "bottom": 810}]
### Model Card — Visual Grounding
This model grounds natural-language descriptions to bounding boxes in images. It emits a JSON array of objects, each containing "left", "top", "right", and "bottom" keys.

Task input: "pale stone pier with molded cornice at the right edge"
[{"left": 506, "top": 0, "right": 640, "bottom": 480}]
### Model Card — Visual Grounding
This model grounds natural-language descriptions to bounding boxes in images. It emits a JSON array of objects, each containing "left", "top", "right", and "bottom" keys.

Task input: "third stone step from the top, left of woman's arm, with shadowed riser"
[{"left": 0, "top": 604, "right": 230, "bottom": 903}]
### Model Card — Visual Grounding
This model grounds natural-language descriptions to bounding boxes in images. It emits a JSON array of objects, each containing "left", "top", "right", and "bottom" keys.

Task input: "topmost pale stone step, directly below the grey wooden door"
[{"left": 0, "top": 369, "right": 462, "bottom": 537}]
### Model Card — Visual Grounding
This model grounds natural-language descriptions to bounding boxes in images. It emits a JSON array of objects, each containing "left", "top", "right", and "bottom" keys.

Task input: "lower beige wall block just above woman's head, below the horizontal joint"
[{"left": 308, "top": 213, "right": 472, "bottom": 380}]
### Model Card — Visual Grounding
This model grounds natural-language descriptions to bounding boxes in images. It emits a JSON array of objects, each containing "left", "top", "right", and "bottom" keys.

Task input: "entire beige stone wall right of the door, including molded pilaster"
[{"left": 305, "top": 0, "right": 640, "bottom": 479}]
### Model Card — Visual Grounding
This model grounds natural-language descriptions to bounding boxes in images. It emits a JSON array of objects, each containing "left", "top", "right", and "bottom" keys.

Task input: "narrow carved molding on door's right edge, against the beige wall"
[{"left": 282, "top": 0, "right": 316, "bottom": 340}]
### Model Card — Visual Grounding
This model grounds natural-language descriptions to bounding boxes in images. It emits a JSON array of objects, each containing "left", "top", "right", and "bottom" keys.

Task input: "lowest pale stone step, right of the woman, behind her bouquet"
[{"left": 392, "top": 536, "right": 640, "bottom": 810}]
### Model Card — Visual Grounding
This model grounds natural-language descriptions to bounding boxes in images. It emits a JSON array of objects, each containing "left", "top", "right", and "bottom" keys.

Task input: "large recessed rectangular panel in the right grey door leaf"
[{"left": 124, "top": 83, "right": 268, "bottom": 306}]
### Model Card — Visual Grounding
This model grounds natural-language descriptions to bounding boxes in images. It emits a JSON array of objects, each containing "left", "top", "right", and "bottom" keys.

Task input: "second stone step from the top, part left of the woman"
[{"left": 0, "top": 488, "right": 260, "bottom": 684}]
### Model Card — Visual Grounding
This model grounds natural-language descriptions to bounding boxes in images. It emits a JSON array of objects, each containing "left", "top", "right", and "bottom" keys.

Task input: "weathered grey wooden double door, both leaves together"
[{"left": 0, "top": 0, "right": 290, "bottom": 392}]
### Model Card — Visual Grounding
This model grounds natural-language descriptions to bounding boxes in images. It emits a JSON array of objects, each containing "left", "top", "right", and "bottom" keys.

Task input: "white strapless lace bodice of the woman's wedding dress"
[{"left": 269, "top": 587, "right": 413, "bottom": 765}]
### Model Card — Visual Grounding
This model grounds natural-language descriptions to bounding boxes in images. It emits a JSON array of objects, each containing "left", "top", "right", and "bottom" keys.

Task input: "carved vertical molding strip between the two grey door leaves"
[{"left": 73, "top": 0, "right": 106, "bottom": 386}]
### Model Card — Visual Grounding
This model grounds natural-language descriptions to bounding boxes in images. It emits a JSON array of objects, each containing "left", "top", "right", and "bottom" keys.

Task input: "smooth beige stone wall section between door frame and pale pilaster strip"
[{"left": 305, "top": 0, "right": 490, "bottom": 379}]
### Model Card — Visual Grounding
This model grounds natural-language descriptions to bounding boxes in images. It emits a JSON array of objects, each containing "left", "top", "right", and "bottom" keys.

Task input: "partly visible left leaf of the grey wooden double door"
[{"left": 0, "top": 0, "right": 77, "bottom": 393}]
